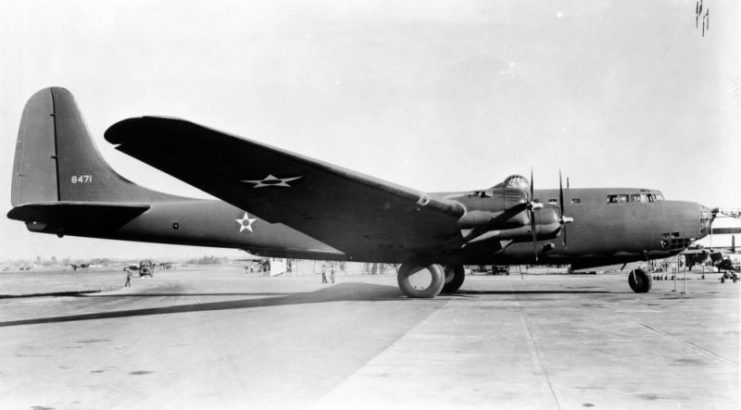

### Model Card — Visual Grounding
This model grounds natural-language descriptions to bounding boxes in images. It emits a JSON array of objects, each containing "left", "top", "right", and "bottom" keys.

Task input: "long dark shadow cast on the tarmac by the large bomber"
[{"left": 0, "top": 283, "right": 611, "bottom": 327}]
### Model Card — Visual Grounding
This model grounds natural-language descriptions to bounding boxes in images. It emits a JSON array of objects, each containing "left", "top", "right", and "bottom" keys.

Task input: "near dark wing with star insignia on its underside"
[{"left": 105, "top": 117, "right": 465, "bottom": 255}]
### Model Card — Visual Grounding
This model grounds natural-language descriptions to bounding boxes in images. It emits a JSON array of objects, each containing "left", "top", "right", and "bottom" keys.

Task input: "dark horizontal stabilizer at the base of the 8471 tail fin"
[{"left": 8, "top": 201, "right": 150, "bottom": 236}]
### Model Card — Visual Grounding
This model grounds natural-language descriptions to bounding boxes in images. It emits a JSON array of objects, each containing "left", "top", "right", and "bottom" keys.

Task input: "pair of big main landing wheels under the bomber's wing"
[{"left": 397, "top": 262, "right": 465, "bottom": 298}]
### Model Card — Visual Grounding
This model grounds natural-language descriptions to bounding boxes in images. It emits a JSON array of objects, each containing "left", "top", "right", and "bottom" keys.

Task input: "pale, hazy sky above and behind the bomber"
[{"left": 0, "top": 0, "right": 741, "bottom": 259}]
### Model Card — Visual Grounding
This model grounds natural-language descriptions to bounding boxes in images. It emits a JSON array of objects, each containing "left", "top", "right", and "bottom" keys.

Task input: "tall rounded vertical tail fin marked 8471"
[{"left": 11, "top": 87, "right": 174, "bottom": 206}]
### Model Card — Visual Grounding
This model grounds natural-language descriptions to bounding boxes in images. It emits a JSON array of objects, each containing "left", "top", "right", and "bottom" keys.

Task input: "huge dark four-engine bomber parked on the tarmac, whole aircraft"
[{"left": 2, "top": 87, "right": 714, "bottom": 298}]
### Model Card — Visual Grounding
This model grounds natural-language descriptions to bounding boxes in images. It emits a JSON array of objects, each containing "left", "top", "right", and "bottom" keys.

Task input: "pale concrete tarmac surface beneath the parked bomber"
[{"left": 0, "top": 268, "right": 740, "bottom": 410}]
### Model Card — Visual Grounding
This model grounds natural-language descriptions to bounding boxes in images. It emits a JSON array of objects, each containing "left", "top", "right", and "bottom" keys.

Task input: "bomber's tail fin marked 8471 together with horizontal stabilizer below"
[{"left": 8, "top": 87, "right": 184, "bottom": 235}]
